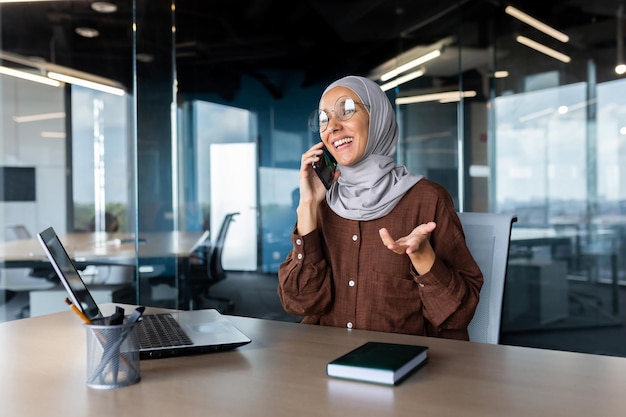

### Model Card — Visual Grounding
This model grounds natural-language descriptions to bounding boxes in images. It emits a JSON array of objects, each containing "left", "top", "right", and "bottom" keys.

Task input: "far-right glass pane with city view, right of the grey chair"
[{"left": 490, "top": 3, "right": 624, "bottom": 352}]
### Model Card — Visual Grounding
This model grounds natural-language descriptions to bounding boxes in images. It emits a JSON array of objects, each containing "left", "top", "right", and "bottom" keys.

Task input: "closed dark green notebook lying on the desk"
[{"left": 326, "top": 342, "right": 428, "bottom": 385}]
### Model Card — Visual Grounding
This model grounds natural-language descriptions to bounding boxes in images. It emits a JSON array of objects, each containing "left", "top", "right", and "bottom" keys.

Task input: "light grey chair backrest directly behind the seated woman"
[{"left": 458, "top": 213, "right": 517, "bottom": 344}]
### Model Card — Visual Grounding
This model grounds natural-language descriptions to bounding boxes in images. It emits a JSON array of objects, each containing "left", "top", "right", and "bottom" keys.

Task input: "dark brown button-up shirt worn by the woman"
[{"left": 278, "top": 179, "right": 483, "bottom": 340}]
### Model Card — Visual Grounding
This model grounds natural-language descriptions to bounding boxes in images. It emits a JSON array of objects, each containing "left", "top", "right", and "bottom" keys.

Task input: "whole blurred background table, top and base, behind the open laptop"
[{"left": 0, "top": 231, "right": 202, "bottom": 315}]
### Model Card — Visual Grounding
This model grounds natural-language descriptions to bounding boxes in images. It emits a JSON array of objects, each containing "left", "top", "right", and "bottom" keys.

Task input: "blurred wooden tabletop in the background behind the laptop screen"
[{"left": 0, "top": 232, "right": 204, "bottom": 266}]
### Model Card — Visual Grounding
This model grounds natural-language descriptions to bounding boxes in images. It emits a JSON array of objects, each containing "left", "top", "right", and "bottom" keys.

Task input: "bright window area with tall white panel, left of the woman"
[{"left": 179, "top": 101, "right": 259, "bottom": 271}]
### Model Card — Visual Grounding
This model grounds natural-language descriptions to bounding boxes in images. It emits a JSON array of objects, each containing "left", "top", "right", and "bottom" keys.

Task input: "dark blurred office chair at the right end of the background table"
[{"left": 183, "top": 212, "right": 240, "bottom": 313}]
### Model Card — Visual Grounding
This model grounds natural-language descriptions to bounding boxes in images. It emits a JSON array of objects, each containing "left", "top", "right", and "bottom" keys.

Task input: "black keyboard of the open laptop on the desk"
[{"left": 137, "top": 313, "right": 193, "bottom": 349}]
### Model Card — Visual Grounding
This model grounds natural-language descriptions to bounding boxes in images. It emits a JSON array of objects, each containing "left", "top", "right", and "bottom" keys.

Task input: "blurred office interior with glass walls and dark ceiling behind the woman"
[{"left": 0, "top": 0, "right": 626, "bottom": 356}]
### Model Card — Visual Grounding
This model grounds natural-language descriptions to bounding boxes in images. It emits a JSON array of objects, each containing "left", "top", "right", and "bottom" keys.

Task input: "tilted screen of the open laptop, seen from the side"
[{"left": 37, "top": 227, "right": 102, "bottom": 319}]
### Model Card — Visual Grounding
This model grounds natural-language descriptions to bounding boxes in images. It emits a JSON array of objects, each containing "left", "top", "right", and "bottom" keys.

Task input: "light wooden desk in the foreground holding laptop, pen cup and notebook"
[{"left": 0, "top": 305, "right": 626, "bottom": 417}]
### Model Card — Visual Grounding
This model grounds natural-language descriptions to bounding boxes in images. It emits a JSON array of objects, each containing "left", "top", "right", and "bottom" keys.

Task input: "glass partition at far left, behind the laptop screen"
[{"left": 0, "top": 1, "right": 137, "bottom": 320}]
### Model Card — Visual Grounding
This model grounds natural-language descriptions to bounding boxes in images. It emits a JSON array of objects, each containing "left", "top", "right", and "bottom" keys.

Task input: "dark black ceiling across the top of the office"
[{"left": 0, "top": 0, "right": 618, "bottom": 99}]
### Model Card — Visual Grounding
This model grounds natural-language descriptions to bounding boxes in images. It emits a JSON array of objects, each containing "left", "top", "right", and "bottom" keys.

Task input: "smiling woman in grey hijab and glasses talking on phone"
[{"left": 278, "top": 76, "right": 483, "bottom": 340}]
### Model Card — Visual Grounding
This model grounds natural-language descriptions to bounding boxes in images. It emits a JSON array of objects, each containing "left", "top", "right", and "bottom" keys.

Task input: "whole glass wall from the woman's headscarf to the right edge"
[{"left": 376, "top": 2, "right": 625, "bottom": 354}]
